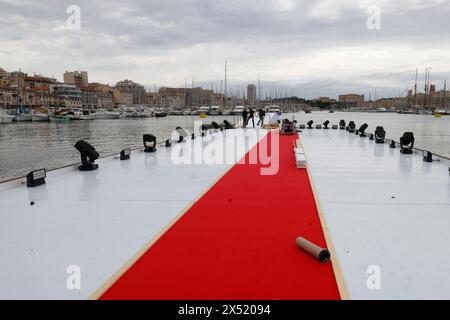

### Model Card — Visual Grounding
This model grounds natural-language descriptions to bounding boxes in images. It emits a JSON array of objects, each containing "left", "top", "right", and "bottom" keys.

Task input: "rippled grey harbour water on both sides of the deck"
[{"left": 0, "top": 112, "right": 450, "bottom": 180}]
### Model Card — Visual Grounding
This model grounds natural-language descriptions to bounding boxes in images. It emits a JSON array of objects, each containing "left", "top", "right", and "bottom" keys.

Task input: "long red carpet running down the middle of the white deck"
[{"left": 101, "top": 134, "right": 340, "bottom": 300}]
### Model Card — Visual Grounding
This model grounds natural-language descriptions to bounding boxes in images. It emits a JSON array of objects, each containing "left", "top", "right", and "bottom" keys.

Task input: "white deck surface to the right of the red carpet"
[{"left": 300, "top": 129, "right": 450, "bottom": 299}]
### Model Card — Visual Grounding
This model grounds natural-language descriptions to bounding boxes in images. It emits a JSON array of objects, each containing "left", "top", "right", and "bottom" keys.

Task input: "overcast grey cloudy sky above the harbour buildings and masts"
[{"left": 0, "top": 0, "right": 450, "bottom": 98}]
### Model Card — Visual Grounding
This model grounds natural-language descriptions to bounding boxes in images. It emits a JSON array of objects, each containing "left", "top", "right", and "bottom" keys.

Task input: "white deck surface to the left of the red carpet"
[{"left": 0, "top": 130, "right": 267, "bottom": 299}]
